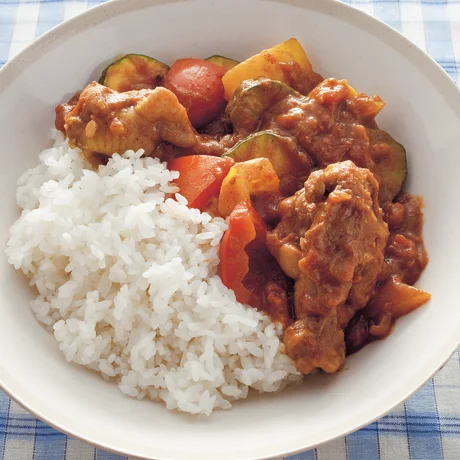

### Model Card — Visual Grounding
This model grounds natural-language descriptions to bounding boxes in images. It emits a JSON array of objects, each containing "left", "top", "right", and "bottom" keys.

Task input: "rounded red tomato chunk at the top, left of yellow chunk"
[{"left": 164, "top": 58, "right": 226, "bottom": 128}]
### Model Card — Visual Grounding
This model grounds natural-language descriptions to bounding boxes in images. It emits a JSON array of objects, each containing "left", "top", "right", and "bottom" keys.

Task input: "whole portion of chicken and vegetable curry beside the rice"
[{"left": 56, "top": 39, "right": 430, "bottom": 374}]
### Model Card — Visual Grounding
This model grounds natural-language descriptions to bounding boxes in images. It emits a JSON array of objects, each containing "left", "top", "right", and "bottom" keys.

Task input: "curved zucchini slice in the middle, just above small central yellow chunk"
[{"left": 222, "top": 131, "right": 311, "bottom": 195}]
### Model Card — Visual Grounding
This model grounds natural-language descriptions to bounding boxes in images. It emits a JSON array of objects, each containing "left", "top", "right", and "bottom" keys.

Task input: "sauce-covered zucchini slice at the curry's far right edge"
[{"left": 367, "top": 128, "right": 407, "bottom": 203}]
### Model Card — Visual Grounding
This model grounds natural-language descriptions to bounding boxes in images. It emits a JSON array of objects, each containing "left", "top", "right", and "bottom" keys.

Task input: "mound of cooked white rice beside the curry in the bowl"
[{"left": 6, "top": 131, "right": 301, "bottom": 415}]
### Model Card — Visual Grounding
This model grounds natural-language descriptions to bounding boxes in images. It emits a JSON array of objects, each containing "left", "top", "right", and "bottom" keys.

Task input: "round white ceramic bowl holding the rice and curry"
[{"left": 0, "top": 0, "right": 460, "bottom": 460}]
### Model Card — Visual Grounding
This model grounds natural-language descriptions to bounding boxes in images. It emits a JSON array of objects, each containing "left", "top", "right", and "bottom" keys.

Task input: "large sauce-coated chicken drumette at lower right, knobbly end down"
[{"left": 267, "top": 161, "right": 388, "bottom": 374}]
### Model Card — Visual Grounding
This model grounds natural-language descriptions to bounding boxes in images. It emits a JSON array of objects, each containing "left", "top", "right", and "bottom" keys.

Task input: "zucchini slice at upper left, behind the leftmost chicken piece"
[{"left": 99, "top": 54, "right": 169, "bottom": 92}]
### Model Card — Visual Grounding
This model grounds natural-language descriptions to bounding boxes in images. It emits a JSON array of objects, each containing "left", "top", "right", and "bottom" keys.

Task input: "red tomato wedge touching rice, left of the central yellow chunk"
[{"left": 168, "top": 155, "right": 235, "bottom": 211}]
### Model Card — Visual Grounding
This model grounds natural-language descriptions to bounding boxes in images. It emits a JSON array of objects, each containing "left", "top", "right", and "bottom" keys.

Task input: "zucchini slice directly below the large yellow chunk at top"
[{"left": 226, "top": 78, "right": 301, "bottom": 133}]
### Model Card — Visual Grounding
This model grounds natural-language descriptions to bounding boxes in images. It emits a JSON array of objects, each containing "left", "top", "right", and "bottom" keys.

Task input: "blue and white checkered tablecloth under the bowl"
[{"left": 0, "top": 0, "right": 460, "bottom": 460}]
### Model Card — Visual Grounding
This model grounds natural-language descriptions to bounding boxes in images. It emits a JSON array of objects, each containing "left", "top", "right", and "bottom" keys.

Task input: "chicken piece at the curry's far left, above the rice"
[{"left": 64, "top": 82, "right": 197, "bottom": 156}]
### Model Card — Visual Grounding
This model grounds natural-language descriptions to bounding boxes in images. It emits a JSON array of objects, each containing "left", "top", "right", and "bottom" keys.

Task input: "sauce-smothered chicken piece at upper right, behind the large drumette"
[{"left": 261, "top": 78, "right": 384, "bottom": 173}]
